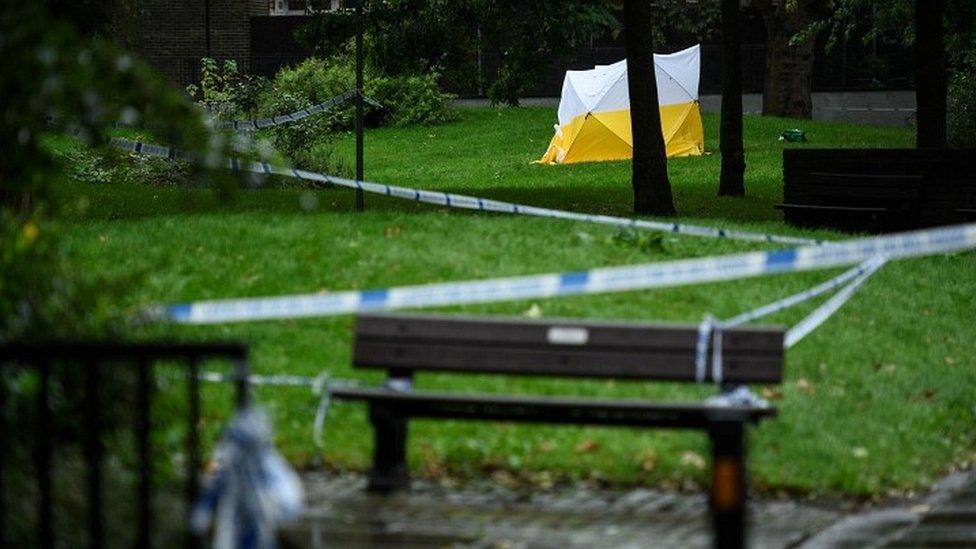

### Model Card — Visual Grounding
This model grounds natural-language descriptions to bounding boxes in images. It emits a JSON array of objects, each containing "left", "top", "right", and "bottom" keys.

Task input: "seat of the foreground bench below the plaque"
[{"left": 332, "top": 388, "right": 776, "bottom": 429}]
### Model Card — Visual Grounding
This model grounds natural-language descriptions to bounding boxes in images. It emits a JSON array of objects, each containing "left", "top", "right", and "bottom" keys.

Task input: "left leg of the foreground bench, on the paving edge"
[{"left": 368, "top": 402, "right": 410, "bottom": 493}]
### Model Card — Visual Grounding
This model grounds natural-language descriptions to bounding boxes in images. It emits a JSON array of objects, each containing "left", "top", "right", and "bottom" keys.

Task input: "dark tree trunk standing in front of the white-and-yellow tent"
[{"left": 624, "top": 0, "right": 675, "bottom": 215}]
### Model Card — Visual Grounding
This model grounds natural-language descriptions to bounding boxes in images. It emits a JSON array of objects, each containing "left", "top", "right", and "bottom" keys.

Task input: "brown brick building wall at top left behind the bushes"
[{"left": 125, "top": 0, "right": 268, "bottom": 84}]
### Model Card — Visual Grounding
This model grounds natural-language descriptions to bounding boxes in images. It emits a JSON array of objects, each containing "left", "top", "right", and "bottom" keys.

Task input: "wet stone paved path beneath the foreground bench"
[{"left": 285, "top": 472, "right": 976, "bottom": 549}]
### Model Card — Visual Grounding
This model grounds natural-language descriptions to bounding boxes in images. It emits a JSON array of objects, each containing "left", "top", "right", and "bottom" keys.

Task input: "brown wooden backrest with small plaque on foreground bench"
[{"left": 353, "top": 314, "right": 784, "bottom": 383}]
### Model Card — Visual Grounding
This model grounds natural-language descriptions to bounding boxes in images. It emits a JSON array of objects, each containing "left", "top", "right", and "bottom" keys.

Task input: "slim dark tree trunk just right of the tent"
[{"left": 718, "top": 0, "right": 746, "bottom": 196}]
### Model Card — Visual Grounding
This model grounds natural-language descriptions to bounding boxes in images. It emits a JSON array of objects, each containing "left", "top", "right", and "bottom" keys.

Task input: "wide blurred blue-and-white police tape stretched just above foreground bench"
[{"left": 154, "top": 224, "right": 976, "bottom": 324}]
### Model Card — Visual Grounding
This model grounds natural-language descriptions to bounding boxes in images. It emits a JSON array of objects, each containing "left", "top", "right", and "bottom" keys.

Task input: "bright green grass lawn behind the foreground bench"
[{"left": 53, "top": 108, "right": 976, "bottom": 495}]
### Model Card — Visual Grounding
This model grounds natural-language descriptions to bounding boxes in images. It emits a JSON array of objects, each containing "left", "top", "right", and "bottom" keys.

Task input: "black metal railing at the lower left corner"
[{"left": 0, "top": 342, "right": 249, "bottom": 548}]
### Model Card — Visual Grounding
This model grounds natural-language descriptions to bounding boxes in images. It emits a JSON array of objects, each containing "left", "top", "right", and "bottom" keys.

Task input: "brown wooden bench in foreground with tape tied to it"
[{"left": 333, "top": 314, "right": 783, "bottom": 546}]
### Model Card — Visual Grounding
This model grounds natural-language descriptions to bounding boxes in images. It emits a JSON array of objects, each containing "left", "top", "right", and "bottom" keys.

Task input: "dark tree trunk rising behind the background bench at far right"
[{"left": 915, "top": 0, "right": 947, "bottom": 149}]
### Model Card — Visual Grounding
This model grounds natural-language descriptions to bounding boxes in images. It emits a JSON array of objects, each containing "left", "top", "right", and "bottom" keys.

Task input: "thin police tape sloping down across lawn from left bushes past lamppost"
[{"left": 112, "top": 138, "right": 822, "bottom": 245}]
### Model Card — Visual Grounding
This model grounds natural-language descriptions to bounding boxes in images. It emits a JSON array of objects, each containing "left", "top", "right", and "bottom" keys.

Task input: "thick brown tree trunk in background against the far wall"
[{"left": 762, "top": 0, "right": 816, "bottom": 118}]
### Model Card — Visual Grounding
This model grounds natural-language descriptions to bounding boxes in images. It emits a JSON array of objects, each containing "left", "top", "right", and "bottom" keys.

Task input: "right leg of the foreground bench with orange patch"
[{"left": 709, "top": 421, "right": 746, "bottom": 549}]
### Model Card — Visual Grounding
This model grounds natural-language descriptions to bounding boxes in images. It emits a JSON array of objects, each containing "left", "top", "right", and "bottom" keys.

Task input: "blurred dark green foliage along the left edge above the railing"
[{"left": 0, "top": 2, "right": 233, "bottom": 340}]
